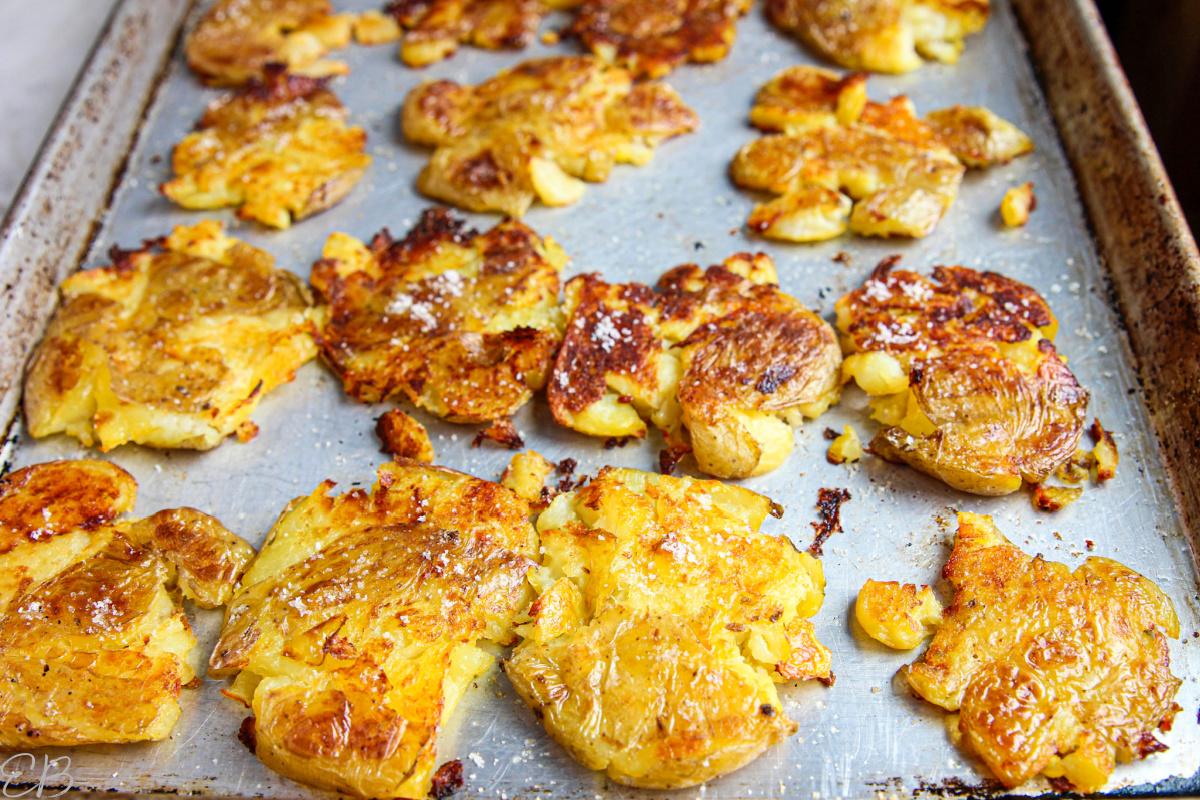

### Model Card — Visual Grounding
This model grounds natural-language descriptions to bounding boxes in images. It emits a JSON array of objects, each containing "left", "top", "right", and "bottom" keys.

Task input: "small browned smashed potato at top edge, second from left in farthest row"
[{"left": 388, "top": 0, "right": 548, "bottom": 67}]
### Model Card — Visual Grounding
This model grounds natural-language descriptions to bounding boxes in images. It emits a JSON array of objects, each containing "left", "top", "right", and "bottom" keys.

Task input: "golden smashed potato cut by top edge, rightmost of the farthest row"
[{"left": 767, "top": 0, "right": 989, "bottom": 72}]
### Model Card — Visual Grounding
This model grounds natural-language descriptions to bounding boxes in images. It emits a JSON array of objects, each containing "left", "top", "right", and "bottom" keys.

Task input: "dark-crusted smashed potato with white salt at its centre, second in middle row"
[{"left": 312, "top": 209, "right": 566, "bottom": 422}]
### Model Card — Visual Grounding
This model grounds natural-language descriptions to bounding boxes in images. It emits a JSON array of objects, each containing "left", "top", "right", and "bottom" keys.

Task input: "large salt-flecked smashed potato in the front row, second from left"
[{"left": 209, "top": 462, "right": 538, "bottom": 798}]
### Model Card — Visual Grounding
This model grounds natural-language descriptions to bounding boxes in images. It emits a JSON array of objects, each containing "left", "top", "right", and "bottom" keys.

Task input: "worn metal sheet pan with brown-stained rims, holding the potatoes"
[{"left": 0, "top": 0, "right": 1200, "bottom": 799}]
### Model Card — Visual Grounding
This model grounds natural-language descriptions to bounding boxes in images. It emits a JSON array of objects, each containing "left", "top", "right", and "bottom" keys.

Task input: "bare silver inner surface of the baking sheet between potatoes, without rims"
[{"left": 0, "top": 0, "right": 1200, "bottom": 799}]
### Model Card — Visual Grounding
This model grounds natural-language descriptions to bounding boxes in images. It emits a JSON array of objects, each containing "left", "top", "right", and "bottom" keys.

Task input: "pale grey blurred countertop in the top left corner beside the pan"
[{"left": 0, "top": 0, "right": 118, "bottom": 217}]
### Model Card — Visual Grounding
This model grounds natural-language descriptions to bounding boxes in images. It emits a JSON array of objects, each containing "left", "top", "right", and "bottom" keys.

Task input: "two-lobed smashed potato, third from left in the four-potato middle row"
[{"left": 547, "top": 253, "right": 841, "bottom": 477}]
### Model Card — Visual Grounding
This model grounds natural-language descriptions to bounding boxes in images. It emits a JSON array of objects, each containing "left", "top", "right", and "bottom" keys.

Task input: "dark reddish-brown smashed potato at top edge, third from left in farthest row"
[{"left": 569, "top": 0, "right": 750, "bottom": 78}]
